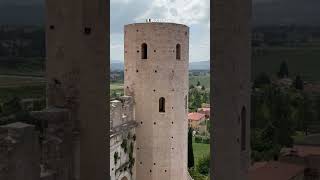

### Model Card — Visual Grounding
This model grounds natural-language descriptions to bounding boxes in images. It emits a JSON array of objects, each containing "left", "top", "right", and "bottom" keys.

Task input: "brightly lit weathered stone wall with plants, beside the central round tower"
[{"left": 110, "top": 96, "right": 137, "bottom": 180}]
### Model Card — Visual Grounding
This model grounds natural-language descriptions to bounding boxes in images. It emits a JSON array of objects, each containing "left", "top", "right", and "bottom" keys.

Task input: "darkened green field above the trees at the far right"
[{"left": 252, "top": 47, "right": 320, "bottom": 81}]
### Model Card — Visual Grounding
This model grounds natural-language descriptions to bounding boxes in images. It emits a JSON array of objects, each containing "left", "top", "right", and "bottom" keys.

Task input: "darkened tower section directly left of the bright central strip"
[{"left": 46, "top": 0, "right": 109, "bottom": 180}]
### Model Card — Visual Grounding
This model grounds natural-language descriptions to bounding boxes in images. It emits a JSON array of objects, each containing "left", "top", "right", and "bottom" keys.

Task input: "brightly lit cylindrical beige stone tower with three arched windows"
[{"left": 124, "top": 22, "right": 189, "bottom": 180}]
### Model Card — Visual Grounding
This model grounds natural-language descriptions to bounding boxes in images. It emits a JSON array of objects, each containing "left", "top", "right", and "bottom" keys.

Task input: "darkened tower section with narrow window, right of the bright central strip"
[{"left": 211, "top": 0, "right": 251, "bottom": 180}]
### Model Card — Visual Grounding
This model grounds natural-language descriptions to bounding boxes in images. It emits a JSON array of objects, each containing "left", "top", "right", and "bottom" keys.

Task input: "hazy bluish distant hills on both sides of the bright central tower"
[{"left": 110, "top": 60, "right": 210, "bottom": 70}]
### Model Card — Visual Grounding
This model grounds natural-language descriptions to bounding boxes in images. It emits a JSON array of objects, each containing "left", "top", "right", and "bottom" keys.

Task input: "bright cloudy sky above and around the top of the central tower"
[{"left": 110, "top": 0, "right": 210, "bottom": 61}]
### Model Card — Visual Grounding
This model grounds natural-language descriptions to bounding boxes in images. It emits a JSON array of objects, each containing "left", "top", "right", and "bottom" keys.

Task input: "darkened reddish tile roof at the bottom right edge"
[{"left": 249, "top": 161, "right": 305, "bottom": 180}]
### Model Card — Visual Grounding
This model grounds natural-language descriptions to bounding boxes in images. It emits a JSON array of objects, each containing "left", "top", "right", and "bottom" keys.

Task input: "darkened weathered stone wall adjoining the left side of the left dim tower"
[{"left": 31, "top": 107, "right": 74, "bottom": 180}]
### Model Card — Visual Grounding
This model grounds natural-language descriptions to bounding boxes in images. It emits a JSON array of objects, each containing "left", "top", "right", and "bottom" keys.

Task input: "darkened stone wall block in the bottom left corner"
[{"left": 0, "top": 122, "right": 40, "bottom": 180}]
